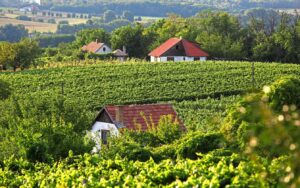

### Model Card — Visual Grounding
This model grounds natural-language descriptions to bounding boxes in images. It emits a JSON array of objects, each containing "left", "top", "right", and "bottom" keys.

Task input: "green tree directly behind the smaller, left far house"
[{"left": 76, "top": 29, "right": 110, "bottom": 47}]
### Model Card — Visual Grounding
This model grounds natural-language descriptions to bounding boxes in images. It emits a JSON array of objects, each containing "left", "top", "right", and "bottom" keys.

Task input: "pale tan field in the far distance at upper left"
[{"left": 0, "top": 18, "right": 57, "bottom": 32}]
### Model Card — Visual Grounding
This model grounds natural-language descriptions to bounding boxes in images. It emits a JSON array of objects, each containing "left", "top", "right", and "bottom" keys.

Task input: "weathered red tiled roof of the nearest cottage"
[{"left": 105, "top": 104, "right": 186, "bottom": 131}]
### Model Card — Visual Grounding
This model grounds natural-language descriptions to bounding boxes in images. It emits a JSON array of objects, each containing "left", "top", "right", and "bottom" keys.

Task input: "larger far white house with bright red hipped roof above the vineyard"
[{"left": 148, "top": 38, "right": 208, "bottom": 62}]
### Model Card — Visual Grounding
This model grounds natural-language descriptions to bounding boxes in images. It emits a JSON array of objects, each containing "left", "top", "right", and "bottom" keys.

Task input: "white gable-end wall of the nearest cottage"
[{"left": 88, "top": 121, "right": 119, "bottom": 153}]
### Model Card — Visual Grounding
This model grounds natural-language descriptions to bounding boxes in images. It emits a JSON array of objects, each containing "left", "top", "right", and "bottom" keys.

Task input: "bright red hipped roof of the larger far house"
[{"left": 148, "top": 38, "right": 208, "bottom": 57}]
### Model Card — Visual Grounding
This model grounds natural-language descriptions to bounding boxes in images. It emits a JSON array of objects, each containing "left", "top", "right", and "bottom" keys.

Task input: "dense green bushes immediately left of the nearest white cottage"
[{"left": 0, "top": 96, "right": 91, "bottom": 162}]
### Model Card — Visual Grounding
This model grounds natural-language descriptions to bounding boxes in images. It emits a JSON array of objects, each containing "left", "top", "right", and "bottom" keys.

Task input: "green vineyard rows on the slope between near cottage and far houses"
[{"left": 0, "top": 61, "right": 300, "bottom": 128}]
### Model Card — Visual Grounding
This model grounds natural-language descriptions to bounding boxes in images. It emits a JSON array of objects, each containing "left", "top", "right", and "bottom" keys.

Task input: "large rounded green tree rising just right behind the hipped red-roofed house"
[{"left": 192, "top": 12, "right": 246, "bottom": 59}]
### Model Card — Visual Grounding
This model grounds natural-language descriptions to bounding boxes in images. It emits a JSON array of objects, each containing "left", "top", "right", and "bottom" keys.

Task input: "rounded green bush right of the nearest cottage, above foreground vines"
[{"left": 177, "top": 132, "right": 224, "bottom": 159}]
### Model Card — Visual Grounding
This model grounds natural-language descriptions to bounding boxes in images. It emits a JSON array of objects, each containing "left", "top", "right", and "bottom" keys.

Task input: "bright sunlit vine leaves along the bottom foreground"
[{"left": 0, "top": 154, "right": 278, "bottom": 187}]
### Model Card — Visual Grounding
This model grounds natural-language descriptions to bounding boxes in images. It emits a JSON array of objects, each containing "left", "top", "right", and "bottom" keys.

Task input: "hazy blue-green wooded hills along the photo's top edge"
[{"left": 36, "top": 0, "right": 300, "bottom": 17}]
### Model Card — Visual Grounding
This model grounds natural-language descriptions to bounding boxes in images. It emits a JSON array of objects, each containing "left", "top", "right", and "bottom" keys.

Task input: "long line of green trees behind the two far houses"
[{"left": 51, "top": 10, "right": 300, "bottom": 63}]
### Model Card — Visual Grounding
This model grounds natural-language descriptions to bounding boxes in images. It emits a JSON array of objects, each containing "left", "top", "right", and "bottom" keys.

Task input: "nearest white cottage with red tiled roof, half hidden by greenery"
[{"left": 92, "top": 104, "right": 185, "bottom": 150}]
